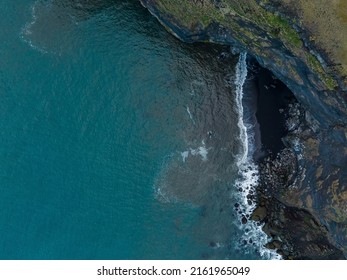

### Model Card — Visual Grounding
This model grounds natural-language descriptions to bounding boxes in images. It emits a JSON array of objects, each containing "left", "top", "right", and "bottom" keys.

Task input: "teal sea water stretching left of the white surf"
[{"left": 0, "top": 0, "right": 278, "bottom": 259}]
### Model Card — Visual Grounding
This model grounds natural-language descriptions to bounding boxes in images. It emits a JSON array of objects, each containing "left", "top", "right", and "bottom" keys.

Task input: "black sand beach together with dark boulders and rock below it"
[{"left": 248, "top": 61, "right": 345, "bottom": 259}]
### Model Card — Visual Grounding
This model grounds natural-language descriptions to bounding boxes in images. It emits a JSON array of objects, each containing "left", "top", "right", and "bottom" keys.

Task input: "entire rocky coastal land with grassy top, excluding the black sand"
[{"left": 140, "top": 0, "right": 347, "bottom": 259}]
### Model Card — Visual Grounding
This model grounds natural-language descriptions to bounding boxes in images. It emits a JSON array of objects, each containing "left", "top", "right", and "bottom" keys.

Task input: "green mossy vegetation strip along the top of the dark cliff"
[{"left": 155, "top": 0, "right": 337, "bottom": 90}]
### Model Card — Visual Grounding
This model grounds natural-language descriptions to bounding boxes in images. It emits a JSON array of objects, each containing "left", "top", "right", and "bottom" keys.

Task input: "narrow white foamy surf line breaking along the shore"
[{"left": 234, "top": 52, "right": 281, "bottom": 259}]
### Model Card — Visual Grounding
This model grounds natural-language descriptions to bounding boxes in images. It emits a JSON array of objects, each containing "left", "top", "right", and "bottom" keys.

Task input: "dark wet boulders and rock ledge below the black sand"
[{"left": 251, "top": 68, "right": 344, "bottom": 259}]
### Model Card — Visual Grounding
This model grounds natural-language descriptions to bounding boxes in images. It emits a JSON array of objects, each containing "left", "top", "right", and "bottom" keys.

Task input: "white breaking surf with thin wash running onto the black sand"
[{"left": 234, "top": 53, "right": 280, "bottom": 259}]
